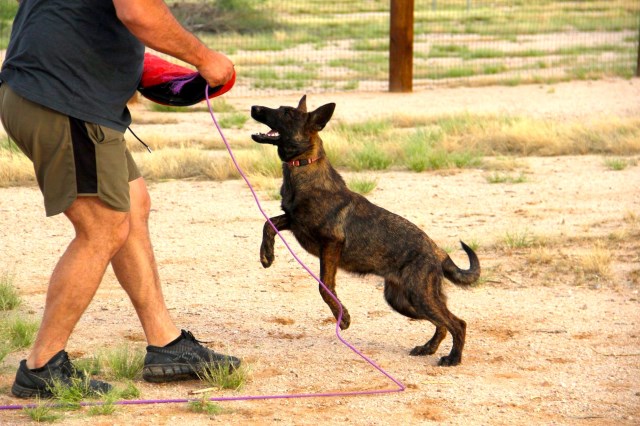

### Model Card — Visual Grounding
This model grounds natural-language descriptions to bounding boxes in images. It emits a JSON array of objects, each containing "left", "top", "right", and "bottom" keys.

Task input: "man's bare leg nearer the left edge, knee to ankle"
[{"left": 27, "top": 197, "right": 129, "bottom": 369}]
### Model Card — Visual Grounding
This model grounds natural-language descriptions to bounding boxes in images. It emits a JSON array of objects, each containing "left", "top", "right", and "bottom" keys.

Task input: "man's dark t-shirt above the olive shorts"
[{"left": 0, "top": 0, "right": 144, "bottom": 131}]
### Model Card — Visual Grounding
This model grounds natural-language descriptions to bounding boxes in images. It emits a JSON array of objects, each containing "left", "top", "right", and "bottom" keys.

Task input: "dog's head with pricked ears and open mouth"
[{"left": 251, "top": 95, "right": 336, "bottom": 161}]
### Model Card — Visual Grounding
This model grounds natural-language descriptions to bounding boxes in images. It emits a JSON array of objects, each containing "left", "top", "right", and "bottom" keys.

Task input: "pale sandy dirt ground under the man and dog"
[{"left": 0, "top": 79, "right": 640, "bottom": 425}]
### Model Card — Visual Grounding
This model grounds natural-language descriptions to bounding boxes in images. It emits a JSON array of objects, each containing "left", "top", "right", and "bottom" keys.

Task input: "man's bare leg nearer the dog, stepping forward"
[{"left": 111, "top": 178, "right": 180, "bottom": 346}]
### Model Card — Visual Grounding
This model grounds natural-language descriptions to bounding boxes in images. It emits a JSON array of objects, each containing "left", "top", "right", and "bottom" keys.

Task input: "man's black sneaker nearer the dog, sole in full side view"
[{"left": 142, "top": 330, "right": 240, "bottom": 383}]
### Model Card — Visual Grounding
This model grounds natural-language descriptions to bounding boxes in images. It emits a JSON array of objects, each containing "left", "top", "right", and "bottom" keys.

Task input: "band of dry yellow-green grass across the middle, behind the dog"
[{"left": 0, "top": 113, "right": 640, "bottom": 187}]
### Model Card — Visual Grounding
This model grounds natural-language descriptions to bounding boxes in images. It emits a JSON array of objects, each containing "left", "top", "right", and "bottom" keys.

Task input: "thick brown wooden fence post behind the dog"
[{"left": 389, "top": 0, "right": 414, "bottom": 92}]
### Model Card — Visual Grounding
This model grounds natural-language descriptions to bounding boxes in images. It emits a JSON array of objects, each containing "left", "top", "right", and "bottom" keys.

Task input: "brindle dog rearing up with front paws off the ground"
[{"left": 251, "top": 95, "right": 480, "bottom": 366}]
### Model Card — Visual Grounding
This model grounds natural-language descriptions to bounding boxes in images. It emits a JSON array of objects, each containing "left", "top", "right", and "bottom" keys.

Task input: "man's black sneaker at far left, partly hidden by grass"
[{"left": 11, "top": 350, "right": 111, "bottom": 398}]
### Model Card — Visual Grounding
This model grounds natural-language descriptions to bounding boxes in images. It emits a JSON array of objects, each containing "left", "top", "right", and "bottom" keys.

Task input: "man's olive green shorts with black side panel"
[{"left": 0, "top": 83, "right": 140, "bottom": 216}]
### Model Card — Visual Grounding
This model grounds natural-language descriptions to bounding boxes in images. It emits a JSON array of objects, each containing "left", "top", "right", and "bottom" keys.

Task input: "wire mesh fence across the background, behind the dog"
[{"left": 0, "top": 0, "right": 640, "bottom": 96}]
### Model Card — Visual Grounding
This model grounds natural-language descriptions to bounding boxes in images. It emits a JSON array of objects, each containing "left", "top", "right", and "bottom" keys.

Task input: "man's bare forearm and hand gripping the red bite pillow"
[{"left": 114, "top": 0, "right": 233, "bottom": 87}]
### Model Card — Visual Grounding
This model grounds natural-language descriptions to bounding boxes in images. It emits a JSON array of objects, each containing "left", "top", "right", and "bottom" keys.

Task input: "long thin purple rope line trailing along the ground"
[{"left": 0, "top": 85, "right": 406, "bottom": 411}]
